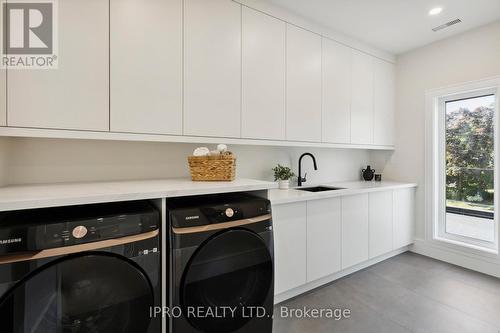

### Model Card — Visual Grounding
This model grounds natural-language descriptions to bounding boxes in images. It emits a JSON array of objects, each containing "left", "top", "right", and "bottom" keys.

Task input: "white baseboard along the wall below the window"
[{"left": 410, "top": 239, "right": 500, "bottom": 278}]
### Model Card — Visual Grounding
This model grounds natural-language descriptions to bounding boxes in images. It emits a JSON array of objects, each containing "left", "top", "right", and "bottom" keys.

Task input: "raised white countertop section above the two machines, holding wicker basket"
[{"left": 0, "top": 179, "right": 277, "bottom": 211}]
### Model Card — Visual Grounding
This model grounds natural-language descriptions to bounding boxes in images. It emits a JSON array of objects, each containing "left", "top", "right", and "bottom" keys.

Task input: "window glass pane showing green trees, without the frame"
[{"left": 444, "top": 94, "right": 495, "bottom": 243}]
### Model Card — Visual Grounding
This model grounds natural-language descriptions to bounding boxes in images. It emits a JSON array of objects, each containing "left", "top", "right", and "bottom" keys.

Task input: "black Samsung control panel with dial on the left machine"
[{"left": 0, "top": 202, "right": 160, "bottom": 255}]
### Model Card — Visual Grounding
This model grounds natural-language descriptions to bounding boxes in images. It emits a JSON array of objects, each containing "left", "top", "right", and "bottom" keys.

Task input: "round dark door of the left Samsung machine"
[{"left": 0, "top": 253, "right": 153, "bottom": 333}]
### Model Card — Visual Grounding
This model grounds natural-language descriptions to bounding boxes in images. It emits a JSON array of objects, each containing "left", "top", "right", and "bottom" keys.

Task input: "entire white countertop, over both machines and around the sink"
[{"left": 0, "top": 179, "right": 417, "bottom": 211}]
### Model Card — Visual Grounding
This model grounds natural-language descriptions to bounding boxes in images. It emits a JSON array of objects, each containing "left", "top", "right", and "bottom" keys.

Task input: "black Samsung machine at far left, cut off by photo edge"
[{"left": 0, "top": 201, "right": 161, "bottom": 333}]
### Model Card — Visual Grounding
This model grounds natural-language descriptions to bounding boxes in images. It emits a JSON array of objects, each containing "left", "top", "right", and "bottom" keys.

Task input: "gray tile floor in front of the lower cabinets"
[{"left": 273, "top": 252, "right": 500, "bottom": 333}]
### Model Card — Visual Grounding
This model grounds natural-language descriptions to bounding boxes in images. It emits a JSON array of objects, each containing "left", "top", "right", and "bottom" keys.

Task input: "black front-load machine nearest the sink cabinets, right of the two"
[{"left": 167, "top": 194, "right": 274, "bottom": 333}]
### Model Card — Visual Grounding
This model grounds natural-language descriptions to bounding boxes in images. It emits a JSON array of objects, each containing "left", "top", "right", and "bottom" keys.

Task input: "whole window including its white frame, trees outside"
[{"left": 426, "top": 80, "right": 500, "bottom": 252}]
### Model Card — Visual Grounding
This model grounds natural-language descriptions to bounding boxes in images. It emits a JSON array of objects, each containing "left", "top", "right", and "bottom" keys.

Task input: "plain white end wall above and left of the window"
[{"left": 384, "top": 22, "right": 500, "bottom": 272}]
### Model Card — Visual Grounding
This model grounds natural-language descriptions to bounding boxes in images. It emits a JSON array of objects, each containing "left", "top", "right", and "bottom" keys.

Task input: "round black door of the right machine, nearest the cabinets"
[{"left": 181, "top": 229, "right": 273, "bottom": 333}]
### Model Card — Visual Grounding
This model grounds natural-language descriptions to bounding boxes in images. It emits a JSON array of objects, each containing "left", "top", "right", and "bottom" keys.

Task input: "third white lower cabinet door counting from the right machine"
[{"left": 342, "top": 194, "right": 368, "bottom": 269}]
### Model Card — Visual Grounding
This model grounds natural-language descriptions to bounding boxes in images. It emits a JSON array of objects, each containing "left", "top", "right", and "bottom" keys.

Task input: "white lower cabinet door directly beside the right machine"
[{"left": 273, "top": 202, "right": 307, "bottom": 295}]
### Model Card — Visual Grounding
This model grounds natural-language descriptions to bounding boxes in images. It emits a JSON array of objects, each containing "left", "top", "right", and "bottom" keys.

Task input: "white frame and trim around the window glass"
[{"left": 426, "top": 77, "right": 500, "bottom": 255}]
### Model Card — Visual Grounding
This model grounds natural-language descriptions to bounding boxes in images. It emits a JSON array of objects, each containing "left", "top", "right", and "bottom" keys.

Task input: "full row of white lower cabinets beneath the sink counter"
[{"left": 273, "top": 188, "right": 415, "bottom": 295}]
